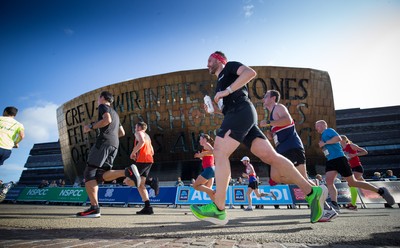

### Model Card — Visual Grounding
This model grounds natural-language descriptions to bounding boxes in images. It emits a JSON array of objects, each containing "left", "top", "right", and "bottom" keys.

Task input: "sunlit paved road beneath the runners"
[{"left": 0, "top": 204, "right": 400, "bottom": 248}]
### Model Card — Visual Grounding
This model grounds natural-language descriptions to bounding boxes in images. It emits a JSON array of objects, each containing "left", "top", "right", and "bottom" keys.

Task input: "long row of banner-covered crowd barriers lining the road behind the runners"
[{"left": 5, "top": 181, "right": 400, "bottom": 207}]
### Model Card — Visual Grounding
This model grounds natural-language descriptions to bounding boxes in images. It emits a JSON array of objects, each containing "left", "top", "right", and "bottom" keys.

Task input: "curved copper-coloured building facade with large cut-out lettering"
[{"left": 57, "top": 66, "right": 336, "bottom": 181}]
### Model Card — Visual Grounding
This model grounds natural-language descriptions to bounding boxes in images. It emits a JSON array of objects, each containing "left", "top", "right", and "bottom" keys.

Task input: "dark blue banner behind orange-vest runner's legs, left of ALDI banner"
[{"left": 128, "top": 186, "right": 177, "bottom": 205}]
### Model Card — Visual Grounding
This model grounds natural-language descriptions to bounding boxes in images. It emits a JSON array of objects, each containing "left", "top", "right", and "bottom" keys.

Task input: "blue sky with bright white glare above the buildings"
[{"left": 0, "top": 0, "right": 400, "bottom": 182}]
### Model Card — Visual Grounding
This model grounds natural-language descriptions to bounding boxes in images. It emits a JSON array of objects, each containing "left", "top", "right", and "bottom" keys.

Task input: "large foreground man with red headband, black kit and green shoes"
[{"left": 190, "top": 51, "right": 327, "bottom": 225}]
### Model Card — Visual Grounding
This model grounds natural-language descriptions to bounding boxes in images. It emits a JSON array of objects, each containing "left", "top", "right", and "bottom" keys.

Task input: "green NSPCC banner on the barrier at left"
[{"left": 17, "top": 187, "right": 87, "bottom": 203}]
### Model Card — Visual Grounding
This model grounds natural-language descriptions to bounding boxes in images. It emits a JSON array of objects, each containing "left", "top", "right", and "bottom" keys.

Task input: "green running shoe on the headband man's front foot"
[{"left": 190, "top": 202, "right": 228, "bottom": 225}]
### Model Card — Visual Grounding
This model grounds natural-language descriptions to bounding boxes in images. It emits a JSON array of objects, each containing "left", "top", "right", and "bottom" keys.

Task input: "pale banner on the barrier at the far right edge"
[{"left": 358, "top": 181, "right": 400, "bottom": 204}]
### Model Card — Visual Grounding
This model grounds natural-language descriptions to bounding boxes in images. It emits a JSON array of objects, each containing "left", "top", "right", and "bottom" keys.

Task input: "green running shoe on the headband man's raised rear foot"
[{"left": 306, "top": 185, "right": 328, "bottom": 223}]
